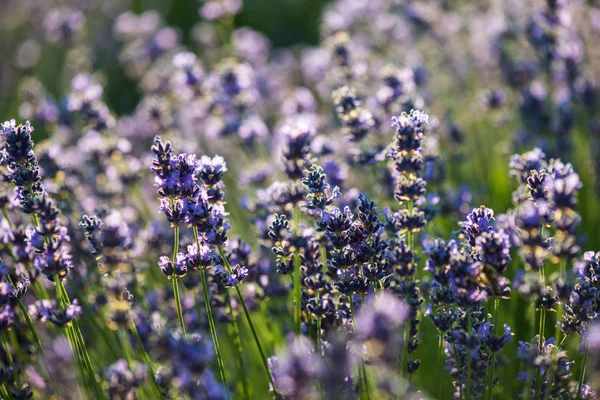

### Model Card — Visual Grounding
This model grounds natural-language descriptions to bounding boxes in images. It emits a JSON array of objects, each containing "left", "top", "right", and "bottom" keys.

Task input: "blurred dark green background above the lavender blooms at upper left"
[{"left": 0, "top": 0, "right": 328, "bottom": 133}]
